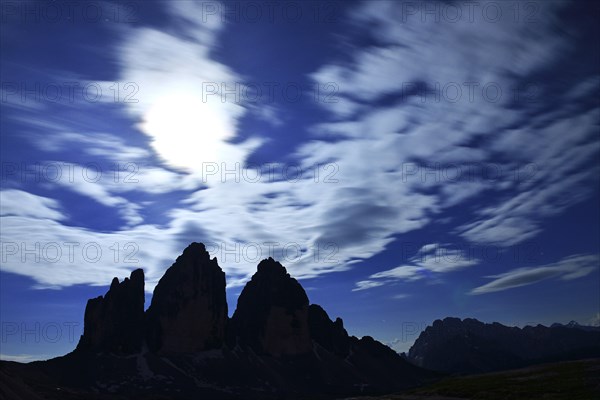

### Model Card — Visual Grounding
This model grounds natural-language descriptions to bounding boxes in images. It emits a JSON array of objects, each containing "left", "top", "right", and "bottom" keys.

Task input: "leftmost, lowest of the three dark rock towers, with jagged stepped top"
[{"left": 77, "top": 269, "right": 144, "bottom": 354}]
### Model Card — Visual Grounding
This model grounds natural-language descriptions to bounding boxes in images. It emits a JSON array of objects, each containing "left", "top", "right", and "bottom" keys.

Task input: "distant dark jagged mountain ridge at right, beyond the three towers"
[{"left": 408, "top": 318, "right": 600, "bottom": 373}]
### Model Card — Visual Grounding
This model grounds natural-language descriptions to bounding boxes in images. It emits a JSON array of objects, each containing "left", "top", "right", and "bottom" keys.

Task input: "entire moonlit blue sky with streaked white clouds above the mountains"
[{"left": 0, "top": 0, "right": 600, "bottom": 360}]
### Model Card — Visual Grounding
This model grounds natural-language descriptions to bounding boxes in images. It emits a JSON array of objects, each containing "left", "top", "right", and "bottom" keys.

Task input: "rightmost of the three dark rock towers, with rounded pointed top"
[{"left": 230, "top": 258, "right": 312, "bottom": 356}]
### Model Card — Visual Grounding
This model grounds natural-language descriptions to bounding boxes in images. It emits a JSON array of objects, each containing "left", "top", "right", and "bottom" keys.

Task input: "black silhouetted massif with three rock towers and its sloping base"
[{"left": 0, "top": 243, "right": 439, "bottom": 400}]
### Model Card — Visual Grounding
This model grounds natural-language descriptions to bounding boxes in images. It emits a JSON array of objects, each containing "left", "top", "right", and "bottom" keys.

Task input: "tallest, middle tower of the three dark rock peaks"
[{"left": 146, "top": 243, "right": 227, "bottom": 354}]
